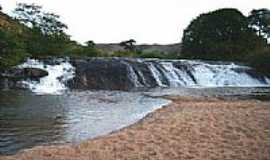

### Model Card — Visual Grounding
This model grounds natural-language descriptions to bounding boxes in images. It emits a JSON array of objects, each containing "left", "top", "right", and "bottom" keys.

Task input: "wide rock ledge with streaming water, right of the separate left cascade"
[{"left": 68, "top": 58, "right": 270, "bottom": 90}]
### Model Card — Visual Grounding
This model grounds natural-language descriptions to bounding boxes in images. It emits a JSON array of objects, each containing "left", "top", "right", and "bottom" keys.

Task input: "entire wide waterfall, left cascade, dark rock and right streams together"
[{"left": 16, "top": 58, "right": 270, "bottom": 94}]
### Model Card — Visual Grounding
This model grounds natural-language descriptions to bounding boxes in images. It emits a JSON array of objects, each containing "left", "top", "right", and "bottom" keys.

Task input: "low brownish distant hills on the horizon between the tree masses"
[{"left": 96, "top": 43, "right": 182, "bottom": 55}]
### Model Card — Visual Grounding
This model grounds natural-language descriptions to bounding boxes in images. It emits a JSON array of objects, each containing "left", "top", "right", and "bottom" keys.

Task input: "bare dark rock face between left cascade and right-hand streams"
[{"left": 68, "top": 58, "right": 154, "bottom": 90}]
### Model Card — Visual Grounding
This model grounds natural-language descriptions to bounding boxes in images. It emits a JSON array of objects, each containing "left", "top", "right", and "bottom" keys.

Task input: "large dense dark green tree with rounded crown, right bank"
[{"left": 182, "top": 9, "right": 265, "bottom": 60}]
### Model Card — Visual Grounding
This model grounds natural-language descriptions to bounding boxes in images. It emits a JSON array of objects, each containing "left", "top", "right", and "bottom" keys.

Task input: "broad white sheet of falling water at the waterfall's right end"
[{"left": 188, "top": 62, "right": 270, "bottom": 87}]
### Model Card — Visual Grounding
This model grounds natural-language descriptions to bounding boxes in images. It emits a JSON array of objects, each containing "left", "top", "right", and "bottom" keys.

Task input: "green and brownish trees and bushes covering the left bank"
[{"left": 0, "top": 3, "right": 99, "bottom": 69}]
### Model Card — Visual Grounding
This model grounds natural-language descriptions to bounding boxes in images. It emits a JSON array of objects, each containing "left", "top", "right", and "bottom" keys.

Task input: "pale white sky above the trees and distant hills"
[{"left": 0, "top": 0, "right": 270, "bottom": 44}]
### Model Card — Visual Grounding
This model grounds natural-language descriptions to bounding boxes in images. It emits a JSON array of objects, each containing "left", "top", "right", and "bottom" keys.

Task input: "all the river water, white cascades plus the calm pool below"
[{"left": 0, "top": 59, "right": 270, "bottom": 155}]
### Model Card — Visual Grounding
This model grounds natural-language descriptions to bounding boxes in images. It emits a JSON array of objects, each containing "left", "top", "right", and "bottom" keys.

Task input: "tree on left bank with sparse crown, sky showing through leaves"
[{"left": 14, "top": 3, "right": 70, "bottom": 56}]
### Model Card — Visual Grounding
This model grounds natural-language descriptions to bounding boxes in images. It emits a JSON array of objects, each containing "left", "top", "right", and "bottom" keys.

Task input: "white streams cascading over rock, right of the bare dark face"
[{"left": 115, "top": 59, "right": 270, "bottom": 87}]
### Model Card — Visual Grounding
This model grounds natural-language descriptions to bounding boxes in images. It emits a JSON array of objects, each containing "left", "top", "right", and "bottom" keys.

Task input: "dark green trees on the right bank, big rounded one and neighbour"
[{"left": 182, "top": 8, "right": 270, "bottom": 73}]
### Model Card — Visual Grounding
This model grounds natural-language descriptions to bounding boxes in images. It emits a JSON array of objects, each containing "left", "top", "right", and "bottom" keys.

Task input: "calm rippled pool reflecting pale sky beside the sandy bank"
[{"left": 0, "top": 91, "right": 169, "bottom": 155}]
